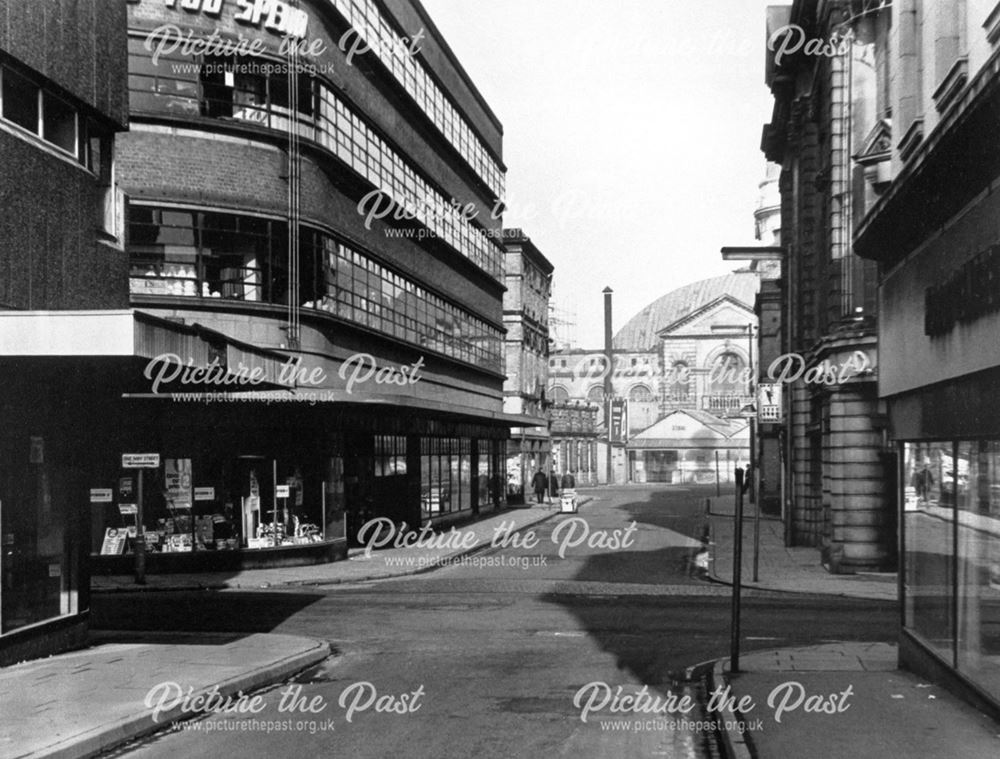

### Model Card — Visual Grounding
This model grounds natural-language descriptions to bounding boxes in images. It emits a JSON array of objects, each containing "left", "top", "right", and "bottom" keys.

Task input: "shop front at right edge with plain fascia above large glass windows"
[{"left": 856, "top": 108, "right": 1000, "bottom": 717}]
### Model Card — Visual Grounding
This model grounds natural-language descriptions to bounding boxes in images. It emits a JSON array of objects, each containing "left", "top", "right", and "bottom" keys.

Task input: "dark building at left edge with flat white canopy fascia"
[{"left": 0, "top": 0, "right": 128, "bottom": 665}]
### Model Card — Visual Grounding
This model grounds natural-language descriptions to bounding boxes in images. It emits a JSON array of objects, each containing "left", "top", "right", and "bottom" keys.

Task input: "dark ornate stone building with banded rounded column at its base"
[{"left": 762, "top": 0, "right": 896, "bottom": 573}]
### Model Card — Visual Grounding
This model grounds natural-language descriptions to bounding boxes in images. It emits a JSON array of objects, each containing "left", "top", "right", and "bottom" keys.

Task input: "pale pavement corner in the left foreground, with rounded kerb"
[{"left": 0, "top": 633, "right": 330, "bottom": 759}]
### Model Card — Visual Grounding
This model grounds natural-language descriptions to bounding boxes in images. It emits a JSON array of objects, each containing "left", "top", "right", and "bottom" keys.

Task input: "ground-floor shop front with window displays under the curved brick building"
[{"left": 88, "top": 399, "right": 506, "bottom": 574}]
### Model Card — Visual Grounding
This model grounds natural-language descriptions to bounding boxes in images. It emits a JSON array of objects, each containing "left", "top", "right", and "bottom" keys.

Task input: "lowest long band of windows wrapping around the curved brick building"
[{"left": 128, "top": 205, "right": 501, "bottom": 372}]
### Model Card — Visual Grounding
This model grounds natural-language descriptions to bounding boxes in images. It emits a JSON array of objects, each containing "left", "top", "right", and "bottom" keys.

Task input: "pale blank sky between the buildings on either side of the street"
[{"left": 422, "top": 0, "right": 780, "bottom": 348}]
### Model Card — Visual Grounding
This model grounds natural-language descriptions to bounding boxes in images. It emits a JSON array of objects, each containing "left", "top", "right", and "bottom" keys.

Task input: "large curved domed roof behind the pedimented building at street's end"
[{"left": 614, "top": 269, "right": 758, "bottom": 351}]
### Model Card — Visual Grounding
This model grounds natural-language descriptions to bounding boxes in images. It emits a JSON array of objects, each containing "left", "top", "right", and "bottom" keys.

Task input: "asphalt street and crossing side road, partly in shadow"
[{"left": 93, "top": 486, "right": 896, "bottom": 757}]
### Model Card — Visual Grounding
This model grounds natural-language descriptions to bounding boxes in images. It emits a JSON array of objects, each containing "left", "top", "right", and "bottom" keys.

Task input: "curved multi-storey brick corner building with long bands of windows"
[{"left": 109, "top": 0, "right": 517, "bottom": 546}]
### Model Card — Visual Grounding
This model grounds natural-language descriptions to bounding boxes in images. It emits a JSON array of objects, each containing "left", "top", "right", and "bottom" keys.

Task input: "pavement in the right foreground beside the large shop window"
[{"left": 710, "top": 643, "right": 1000, "bottom": 759}]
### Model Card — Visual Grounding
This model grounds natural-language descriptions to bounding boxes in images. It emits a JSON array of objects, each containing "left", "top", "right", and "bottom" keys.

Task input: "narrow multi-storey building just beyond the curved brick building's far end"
[{"left": 503, "top": 229, "right": 553, "bottom": 500}]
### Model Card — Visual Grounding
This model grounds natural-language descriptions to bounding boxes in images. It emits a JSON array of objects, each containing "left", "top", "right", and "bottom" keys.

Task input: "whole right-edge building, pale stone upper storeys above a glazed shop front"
[{"left": 854, "top": 0, "right": 1000, "bottom": 717}]
